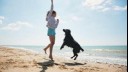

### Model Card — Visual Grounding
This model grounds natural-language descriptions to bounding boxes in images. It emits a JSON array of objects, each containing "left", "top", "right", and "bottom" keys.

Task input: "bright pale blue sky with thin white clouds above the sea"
[{"left": 0, "top": 0, "right": 127, "bottom": 46}]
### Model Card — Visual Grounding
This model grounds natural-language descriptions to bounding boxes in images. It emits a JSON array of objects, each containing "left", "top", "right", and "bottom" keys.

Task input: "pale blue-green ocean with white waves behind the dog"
[{"left": 5, "top": 45, "right": 127, "bottom": 66}]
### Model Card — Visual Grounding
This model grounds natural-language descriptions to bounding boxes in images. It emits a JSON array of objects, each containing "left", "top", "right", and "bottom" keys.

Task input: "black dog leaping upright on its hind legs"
[{"left": 60, "top": 29, "right": 84, "bottom": 60}]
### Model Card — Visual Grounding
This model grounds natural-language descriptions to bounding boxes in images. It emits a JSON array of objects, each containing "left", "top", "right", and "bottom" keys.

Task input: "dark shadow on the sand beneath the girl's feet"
[{"left": 37, "top": 60, "right": 55, "bottom": 72}]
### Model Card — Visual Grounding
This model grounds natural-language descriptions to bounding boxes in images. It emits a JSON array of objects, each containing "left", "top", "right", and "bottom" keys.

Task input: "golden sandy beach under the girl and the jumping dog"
[{"left": 0, "top": 46, "right": 127, "bottom": 72}]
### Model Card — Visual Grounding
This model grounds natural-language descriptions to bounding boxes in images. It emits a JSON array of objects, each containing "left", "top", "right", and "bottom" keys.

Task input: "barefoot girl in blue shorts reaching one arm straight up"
[{"left": 44, "top": 0, "right": 59, "bottom": 60}]
